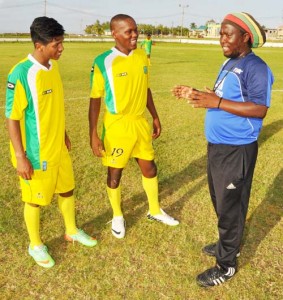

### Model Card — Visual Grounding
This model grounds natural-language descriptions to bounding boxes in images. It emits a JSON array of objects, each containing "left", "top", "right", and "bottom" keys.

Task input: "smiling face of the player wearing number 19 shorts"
[{"left": 112, "top": 18, "right": 139, "bottom": 55}]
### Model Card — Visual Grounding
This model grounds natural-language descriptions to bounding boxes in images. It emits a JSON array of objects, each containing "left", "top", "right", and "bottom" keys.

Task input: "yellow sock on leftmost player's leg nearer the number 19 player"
[{"left": 58, "top": 195, "right": 78, "bottom": 235}]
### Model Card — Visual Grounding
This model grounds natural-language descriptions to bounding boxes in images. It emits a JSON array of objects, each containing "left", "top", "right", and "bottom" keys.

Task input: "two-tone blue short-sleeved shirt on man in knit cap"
[{"left": 205, "top": 52, "right": 274, "bottom": 145}]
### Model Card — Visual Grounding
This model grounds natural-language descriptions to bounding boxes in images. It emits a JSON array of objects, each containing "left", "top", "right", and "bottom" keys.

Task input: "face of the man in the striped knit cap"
[{"left": 220, "top": 23, "right": 249, "bottom": 58}]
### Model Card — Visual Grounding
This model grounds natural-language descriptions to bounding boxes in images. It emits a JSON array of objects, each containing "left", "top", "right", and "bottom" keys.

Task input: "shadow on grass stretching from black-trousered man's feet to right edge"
[{"left": 241, "top": 169, "right": 283, "bottom": 265}]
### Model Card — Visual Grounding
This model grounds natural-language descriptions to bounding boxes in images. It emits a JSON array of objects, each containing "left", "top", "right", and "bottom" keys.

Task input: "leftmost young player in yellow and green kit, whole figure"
[{"left": 6, "top": 17, "right": 97, "bottom": 268}]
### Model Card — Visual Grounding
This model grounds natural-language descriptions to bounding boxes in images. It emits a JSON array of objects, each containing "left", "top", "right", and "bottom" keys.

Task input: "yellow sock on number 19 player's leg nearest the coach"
[{"left": 142, "top": 176, "right": 161, "bottom": 215}]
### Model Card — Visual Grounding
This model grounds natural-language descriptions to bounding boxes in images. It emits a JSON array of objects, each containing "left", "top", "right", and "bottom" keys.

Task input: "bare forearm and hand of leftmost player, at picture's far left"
[{"left": 7, "top": 119, "right": 33, "bottom": 180}]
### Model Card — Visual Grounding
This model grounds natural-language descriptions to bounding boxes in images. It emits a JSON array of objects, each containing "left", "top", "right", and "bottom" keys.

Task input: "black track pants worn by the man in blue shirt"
[{"left": 207, "top": 142, "right": 258, "bottom": 269}]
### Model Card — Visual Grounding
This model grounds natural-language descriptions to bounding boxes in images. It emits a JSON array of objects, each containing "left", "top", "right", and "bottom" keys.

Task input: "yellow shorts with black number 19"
[{"left": 102, "top": 114, "right": 154, "bottom": 168}]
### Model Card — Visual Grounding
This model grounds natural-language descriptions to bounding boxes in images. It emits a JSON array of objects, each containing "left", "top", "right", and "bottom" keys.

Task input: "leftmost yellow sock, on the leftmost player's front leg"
[{"left": 24, "top": 203, "right": 42, "bottom": 249}]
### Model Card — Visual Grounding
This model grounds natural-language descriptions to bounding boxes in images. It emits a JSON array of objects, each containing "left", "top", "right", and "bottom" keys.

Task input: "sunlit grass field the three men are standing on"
[{"left": 0, "top": 43, "right": 283, "bottom": 300}]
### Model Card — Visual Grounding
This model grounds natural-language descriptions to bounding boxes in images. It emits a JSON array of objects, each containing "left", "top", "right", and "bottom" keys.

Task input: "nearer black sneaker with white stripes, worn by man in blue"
[{"left": 197, "top": 265, "right": 236, "bottom": 287}]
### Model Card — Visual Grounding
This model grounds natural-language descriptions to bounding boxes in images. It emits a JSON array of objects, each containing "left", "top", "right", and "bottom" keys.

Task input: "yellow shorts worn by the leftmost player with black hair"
[{"left": 20, "top": 148, "right": 75, "bottom": 206}]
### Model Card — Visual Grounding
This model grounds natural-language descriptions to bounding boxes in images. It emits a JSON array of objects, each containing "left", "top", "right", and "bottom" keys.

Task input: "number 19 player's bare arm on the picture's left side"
[{"left": 88, "top": 98, "right": 104, "bottom": 157}]
